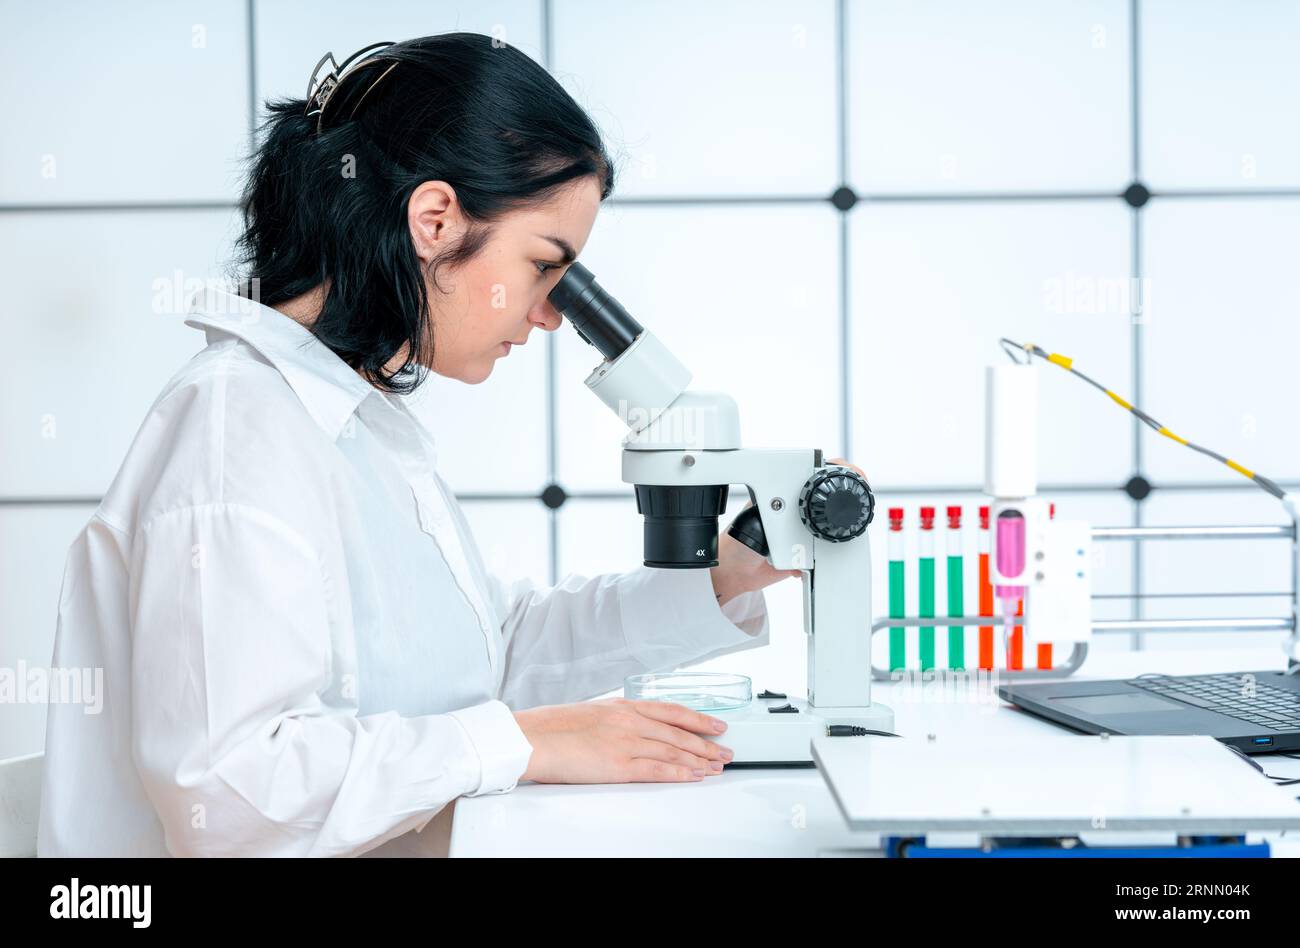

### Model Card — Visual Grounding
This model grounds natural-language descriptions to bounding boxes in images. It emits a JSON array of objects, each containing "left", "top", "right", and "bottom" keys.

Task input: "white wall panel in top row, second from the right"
[{"left": 848, "top": 0, "right": 1131, "bottom": 192}]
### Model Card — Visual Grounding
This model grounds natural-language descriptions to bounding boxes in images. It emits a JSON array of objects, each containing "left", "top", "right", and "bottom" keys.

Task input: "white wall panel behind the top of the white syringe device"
[{"left": 850, "top": 200, "right": 1132, "bottom": 486}]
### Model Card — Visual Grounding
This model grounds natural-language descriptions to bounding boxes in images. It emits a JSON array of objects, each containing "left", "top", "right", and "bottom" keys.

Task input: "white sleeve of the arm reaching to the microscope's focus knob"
[{"left": 493, "top": 567, "right": 768, "bottom": 709}]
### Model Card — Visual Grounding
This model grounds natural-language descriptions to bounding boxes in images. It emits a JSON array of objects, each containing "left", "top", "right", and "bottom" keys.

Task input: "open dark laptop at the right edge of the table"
[{"left": 997, "top": 666, "right": 1300, "bottom": 754}]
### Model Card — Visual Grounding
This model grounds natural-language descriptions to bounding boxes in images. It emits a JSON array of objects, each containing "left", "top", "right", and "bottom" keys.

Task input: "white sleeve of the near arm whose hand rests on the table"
[{"left": 131, "top": 503, "right": 532, "bottom": 856}]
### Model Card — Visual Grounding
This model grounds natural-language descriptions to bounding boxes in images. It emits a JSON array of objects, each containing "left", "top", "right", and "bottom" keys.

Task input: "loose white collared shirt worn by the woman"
[{"left": 38, "top": 284, "right": 767, "bottom": 856}]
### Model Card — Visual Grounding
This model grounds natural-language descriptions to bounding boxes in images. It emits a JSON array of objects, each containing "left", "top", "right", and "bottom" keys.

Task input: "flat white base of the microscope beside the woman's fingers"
[{"left": 709, "top": 698, "right": 893, "bottom": 767}]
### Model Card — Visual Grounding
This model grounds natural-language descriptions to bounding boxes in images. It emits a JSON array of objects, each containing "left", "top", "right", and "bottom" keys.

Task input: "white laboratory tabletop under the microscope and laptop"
[{"left": 450, "top": 648, "right": 1300, "bottom": 857}]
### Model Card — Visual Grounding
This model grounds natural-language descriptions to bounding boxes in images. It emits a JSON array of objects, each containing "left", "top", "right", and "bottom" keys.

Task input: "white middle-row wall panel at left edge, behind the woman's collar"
[{"left": 0, "top": 209, "right": 237, "bottom": 497}]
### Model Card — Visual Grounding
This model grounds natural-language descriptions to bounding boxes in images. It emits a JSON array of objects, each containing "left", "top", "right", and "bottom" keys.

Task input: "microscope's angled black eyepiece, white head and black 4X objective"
[{"left": 547, "top": 263, "right": 740, "bottom": 570}]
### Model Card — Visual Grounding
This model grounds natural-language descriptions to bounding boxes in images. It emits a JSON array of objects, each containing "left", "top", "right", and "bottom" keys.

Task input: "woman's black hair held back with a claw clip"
[{"left": 239, "top": 33, "right": 614, "bottom": 393}]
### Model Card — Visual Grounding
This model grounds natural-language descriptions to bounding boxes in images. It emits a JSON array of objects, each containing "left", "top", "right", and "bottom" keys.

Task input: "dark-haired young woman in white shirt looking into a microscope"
[{"left": 39, "top": 34, "right": 788, "bottom": 856}]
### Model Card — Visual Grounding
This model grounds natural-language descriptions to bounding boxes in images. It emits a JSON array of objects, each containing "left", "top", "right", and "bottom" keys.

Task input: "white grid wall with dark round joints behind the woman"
[{"left": 0, "top": 0, "right": 1300, "bottom": 757}]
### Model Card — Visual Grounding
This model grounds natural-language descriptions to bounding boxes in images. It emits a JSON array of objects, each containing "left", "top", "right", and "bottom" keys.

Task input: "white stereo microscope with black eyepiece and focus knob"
[{"left": 549, "top": 263, "right": 893, "bottom": 766}]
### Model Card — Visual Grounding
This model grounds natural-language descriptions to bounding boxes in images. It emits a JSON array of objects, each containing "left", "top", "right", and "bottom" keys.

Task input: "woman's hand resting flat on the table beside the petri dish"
[{"left": 515, "top": 698, "right": 732, "bottom": 783}]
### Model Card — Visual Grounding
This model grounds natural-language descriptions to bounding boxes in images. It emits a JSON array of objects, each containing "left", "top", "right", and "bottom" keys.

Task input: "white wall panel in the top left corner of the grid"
[{"left": 0, "top": 0, "right": 250, "bottom": 204}]
